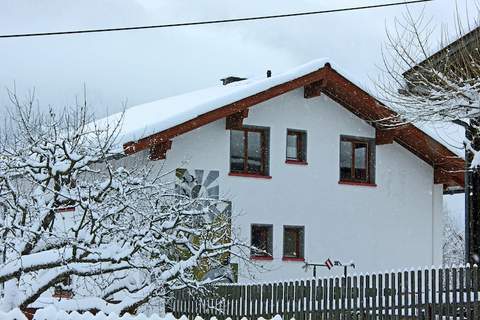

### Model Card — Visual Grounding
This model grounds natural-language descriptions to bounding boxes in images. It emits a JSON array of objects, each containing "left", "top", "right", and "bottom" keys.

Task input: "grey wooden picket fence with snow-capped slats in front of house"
[{"left": 172, "top": 266, "right": 480, "bottom": 320}]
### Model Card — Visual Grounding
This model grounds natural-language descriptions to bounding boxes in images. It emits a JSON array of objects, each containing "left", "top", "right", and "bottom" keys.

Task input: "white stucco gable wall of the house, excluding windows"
[{"left": 134, "top": 90, "right": 442, "bottom": 281}]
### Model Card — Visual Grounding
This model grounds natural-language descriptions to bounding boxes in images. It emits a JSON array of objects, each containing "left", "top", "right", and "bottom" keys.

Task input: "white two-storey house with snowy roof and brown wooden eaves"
[{"left": 100, "top": 59, "right": 464, "bottom": 282}]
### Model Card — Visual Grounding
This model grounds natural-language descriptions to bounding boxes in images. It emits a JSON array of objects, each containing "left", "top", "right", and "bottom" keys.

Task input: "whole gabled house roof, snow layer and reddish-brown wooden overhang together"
[{"left": 97, "top": 59, "right": 464, "bottom": 187}]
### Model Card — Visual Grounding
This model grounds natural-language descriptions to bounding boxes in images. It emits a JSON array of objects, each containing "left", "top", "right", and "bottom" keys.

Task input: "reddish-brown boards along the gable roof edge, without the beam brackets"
[{"left": 124, "top": 64, "right": 464, "bottom": 187}]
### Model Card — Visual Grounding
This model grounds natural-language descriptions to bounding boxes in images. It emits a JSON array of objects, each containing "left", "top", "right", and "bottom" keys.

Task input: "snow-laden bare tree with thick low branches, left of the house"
[{"left": 0, "top": 94, "right": 242, "bottom": 313}]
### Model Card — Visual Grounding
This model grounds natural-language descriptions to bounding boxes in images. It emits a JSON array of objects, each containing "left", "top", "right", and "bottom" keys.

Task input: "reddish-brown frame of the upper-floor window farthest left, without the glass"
[{"left": 230, "top": 127, "right": 268, "bottom": 176}]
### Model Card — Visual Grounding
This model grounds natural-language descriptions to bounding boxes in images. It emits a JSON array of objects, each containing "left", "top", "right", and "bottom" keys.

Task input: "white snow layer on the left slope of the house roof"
[{"left": 96, "top": 59, "right": 328, "bottom": 143}]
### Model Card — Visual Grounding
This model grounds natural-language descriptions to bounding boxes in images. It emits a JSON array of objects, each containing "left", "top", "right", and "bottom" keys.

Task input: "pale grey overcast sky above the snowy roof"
[{"left": 0, "top": 0, "right": 476, "bottom": 226}]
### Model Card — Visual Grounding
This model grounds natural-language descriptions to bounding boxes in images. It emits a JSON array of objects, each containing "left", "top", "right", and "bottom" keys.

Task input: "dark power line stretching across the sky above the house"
[{"left": 0, "top": 0, "right": 433, "bottom": 38}]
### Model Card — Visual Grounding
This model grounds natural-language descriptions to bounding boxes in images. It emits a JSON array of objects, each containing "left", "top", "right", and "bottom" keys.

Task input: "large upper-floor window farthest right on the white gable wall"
[{"left": 340, "top": 136, "right": 375, "bottom": 183}]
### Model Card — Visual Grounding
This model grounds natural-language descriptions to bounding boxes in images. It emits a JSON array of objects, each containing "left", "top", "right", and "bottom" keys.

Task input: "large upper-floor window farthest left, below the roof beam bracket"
[{"left": 230, "top": 127, "right": 268, "bottom": 176}]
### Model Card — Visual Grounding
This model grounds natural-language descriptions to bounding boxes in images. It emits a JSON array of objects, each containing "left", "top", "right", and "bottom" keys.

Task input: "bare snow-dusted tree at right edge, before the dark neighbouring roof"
[{"left": 378, "top": 6, "right": 480, "bottom": 263}]
